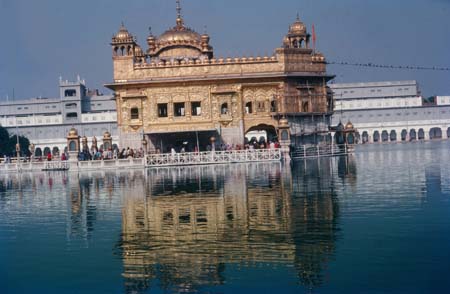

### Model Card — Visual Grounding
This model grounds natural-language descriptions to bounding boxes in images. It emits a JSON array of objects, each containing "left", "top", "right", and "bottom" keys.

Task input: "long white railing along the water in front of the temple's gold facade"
[{"left": 146, "top": 149, "right": 281, "bottom": 167}]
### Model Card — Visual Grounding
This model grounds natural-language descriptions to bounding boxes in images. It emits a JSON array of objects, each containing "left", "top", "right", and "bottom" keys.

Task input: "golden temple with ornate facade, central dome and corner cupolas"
[{"left": 107, "top": 1, "right": 332, "bottom": 148}]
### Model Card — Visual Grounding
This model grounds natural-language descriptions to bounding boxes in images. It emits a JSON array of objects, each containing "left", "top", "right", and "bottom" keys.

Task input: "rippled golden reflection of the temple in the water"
[{"left": 117, "top": 159, "right": 348, "bottom": 292}]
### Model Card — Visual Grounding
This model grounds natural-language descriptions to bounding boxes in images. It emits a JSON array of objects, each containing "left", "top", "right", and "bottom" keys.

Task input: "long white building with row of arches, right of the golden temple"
[{"left": 330, "top": 81, "right": 450, "bottom": 143}]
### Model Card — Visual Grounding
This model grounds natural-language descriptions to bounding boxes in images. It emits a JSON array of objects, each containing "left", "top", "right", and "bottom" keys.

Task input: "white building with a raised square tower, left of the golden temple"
[{"left": 0, "top": 78, "right": 118, "bottom": 156}]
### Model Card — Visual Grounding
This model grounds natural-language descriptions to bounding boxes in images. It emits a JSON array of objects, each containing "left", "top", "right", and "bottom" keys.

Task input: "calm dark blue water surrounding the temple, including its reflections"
[{"left": 0, "top": 142, "right": 450, "bottom": 293}]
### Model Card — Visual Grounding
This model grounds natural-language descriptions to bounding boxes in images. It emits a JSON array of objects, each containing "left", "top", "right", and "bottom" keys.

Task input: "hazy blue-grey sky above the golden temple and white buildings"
[{"left": 0, "top": 0, "right": 450, "bottom": 100}]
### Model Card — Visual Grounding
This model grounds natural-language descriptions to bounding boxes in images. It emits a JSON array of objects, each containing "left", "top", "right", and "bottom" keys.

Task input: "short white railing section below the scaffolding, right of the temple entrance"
[{"left": 291, "top": 144, "right": 354, "bottom": 159}]
